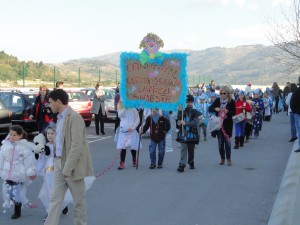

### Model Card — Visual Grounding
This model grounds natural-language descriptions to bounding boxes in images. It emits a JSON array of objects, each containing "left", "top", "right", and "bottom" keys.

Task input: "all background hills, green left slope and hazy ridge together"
[{"left": 0, "top": 45, "right": 300, "bottom": 86}]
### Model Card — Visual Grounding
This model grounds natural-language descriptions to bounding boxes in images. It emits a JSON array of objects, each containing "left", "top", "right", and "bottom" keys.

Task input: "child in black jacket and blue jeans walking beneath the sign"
[{"left": 140, "top": 109, "right": 170, "bottom": 169}]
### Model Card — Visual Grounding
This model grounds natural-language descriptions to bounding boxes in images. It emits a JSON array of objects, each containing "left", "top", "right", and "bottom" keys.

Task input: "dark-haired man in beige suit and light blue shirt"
[{"left": 45, "top": 89, "right": 94, "bottom": 225}]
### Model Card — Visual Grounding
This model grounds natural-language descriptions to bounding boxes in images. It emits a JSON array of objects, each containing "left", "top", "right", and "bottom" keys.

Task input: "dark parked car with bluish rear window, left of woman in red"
[{"left": 0, "top": 90, "right": 38, "bottom": 133}]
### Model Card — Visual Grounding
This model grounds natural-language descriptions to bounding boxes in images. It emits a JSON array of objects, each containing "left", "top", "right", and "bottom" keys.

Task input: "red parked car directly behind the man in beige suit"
[{"left": 65, "top": 90, "right": 92, "bottom": 127}]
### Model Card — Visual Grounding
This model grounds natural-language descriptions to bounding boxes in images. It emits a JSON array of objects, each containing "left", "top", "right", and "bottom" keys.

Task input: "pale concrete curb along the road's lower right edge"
[{"left": 268, "top": 140, "right": 300, "bottom": 225}]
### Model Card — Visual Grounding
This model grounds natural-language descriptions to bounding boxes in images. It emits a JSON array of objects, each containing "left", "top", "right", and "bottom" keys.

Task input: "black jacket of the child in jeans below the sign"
[{"left": 143, "top": 115, "right": 170, "bottom": 142}]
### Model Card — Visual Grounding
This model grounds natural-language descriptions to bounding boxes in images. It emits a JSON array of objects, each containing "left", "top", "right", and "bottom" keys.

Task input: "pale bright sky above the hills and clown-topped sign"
[{"left": 0, "top": 0, "right": 289, "bottom": 63}]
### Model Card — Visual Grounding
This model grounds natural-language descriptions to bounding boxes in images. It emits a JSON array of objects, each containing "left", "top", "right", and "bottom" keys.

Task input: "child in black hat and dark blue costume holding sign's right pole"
[{"left": 176, "top": 95, "right": 201, "bottom": 173}]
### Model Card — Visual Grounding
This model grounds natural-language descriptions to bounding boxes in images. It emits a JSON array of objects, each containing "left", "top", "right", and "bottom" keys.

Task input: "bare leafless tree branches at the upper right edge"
[{"left": 267, "top": 0, "right": 300, "bottom": 73}]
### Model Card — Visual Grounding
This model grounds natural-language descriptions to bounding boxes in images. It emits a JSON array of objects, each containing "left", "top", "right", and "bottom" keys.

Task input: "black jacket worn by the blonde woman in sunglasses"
[{"left": 208, "top": 98, "right": 235, "bottom": 137}]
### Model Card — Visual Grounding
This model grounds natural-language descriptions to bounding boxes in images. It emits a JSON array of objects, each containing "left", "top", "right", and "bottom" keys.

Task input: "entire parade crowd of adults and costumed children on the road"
[{"left": 0, "top": 77, "right": 300, "bottom": 225}]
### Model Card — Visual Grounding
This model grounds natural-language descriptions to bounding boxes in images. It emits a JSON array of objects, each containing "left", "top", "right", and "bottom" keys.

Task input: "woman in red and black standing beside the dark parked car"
[{"left": 29, "top": 85, "right": 53, "bottom": 133}]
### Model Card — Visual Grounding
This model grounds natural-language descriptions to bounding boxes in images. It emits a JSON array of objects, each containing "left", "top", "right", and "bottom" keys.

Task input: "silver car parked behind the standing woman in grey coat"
[{"left": 81, "top": 88, "right": 117, "bottom": 120}]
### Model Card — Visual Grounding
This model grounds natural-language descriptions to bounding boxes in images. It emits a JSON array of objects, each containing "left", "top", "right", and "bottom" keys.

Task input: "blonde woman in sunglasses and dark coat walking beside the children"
[{"left": 208, "top": 86, "right": 235, "bottom": 166}]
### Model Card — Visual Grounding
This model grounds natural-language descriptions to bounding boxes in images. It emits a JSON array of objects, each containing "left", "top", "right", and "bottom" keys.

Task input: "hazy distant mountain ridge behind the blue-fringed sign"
[{"left": 70, "top": 45, "right": 300, "bottom": 85}]
